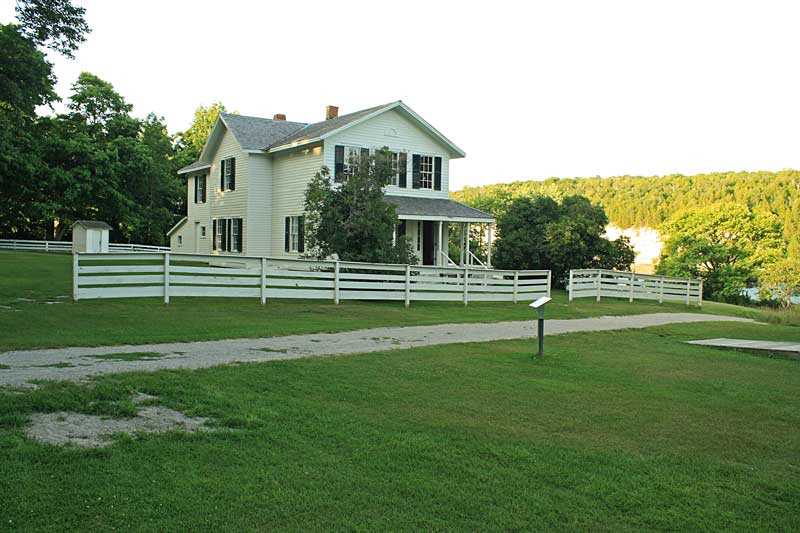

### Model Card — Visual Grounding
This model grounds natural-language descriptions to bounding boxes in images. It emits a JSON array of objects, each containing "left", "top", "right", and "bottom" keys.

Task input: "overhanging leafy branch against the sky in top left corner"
[{"left": 16, "top": 0, "right": 91, "bottom": 58}]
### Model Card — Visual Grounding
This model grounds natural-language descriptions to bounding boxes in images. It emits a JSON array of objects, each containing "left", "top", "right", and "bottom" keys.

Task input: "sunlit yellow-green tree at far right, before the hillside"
[{"left": 658, "top": 203, "right": 786, "bottom": 301}]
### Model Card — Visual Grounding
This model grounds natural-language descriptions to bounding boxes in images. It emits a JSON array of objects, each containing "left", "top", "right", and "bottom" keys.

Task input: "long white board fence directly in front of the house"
[{"left": 73, "top": 252, "right": 550, "bottom": 306}]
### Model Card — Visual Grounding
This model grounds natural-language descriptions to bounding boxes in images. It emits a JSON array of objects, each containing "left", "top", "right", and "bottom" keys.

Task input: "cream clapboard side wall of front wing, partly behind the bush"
[{"left": 269, "top": 145, "right": 323, "bottom": 257}]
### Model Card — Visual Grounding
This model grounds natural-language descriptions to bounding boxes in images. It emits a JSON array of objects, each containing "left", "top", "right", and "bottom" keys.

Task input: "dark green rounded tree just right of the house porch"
[{"left": 495, "top": 196, "right": 634, "bottom": 286}]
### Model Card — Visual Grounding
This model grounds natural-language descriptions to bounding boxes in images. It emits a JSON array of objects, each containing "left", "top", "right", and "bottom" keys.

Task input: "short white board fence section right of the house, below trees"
[{"left": 568, "top": 268, "right": 703, "bottom": 305}]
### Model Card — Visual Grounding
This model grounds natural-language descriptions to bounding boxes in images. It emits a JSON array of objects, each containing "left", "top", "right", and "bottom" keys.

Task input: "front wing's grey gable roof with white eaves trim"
[{"left": 265, "top": 100, "right": 466, "bottom": 157}]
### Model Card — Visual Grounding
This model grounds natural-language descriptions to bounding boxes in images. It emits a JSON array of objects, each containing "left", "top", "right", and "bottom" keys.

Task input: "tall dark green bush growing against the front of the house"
[{"left": 305, "top": 149, "right": 414, "bottom": 263}]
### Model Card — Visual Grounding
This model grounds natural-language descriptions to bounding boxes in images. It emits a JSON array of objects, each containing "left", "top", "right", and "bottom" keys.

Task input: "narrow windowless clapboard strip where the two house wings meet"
[{"left": 247, "top": 154, "right": 272, "bottom": 255}]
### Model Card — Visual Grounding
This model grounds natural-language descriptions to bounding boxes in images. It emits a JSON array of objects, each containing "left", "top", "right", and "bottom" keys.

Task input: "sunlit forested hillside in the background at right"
[{"left": 452, "top": 170, "right": 800, "bottom": 255}]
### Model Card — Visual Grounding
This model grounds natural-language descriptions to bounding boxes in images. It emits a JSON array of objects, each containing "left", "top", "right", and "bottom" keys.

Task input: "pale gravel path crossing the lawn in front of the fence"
[{"left": 0, "top": 313, "right": 749, "bottom": 386}]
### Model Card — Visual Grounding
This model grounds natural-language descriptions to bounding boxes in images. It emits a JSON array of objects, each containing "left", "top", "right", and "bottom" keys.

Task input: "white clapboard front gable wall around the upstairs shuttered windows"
[{"left": 325, "top": 109, "right": 450, "bottom": 198}]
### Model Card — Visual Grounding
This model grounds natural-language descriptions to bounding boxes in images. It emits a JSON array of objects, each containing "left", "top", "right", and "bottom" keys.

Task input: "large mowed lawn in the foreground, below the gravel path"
[{"left": 0, "top": 323, "right": 800, "bottom": 531}]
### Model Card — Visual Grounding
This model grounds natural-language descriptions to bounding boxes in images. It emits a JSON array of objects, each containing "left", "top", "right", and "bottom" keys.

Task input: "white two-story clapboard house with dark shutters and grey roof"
[{"left": 168, "top": 101, "right": 494, "bottom": 265}]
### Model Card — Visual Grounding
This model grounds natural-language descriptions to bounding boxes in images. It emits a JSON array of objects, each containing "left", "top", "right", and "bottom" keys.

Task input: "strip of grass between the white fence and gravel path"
[{"left": 0, "top": 251, "right": 759, "bottom": 351}]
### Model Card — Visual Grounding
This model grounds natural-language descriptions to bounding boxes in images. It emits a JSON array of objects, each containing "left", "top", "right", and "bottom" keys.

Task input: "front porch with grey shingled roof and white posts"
[{"left": 387, "top": 196, "right": 495, "bottom": 268}]
